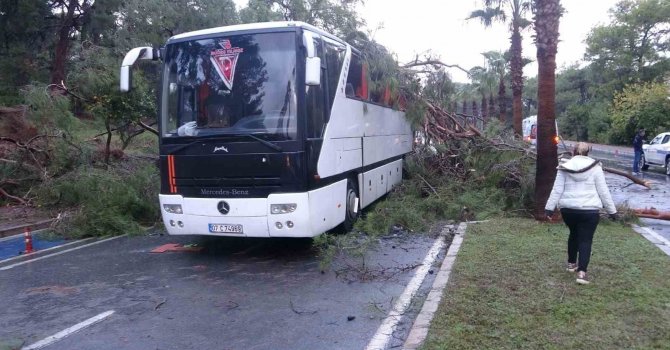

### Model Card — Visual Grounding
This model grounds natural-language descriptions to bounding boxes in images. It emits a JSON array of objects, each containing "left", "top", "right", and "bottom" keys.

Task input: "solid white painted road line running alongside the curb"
[{"left": 365, "top": 232, "right": 444, "bottom": 350}]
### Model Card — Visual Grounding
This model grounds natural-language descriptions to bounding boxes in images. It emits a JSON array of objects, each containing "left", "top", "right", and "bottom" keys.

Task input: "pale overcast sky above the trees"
[{"left": 235, "top": 0, "right": 618, "bottom": 82}]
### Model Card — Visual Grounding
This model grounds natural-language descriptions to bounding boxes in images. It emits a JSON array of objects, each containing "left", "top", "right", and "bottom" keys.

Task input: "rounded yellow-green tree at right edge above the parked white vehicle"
[{"left": 610, "top": 83, "right": 670, "bottom": 143}]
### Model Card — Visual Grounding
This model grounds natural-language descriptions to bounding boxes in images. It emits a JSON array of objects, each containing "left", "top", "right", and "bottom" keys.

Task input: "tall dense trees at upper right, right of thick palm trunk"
[{"left": 524, "top": 0, "right": 670, "bottom": 145}]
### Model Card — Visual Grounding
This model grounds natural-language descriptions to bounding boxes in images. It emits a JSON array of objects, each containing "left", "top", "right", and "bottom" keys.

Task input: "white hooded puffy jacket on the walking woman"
[{"left": 544, "top": 156, "right": 616, "bottom": 214}]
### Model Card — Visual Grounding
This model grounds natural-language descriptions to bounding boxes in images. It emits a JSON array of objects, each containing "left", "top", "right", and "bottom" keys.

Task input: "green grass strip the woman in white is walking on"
[{"left": 423, "top": 219, "right": 670, "bottom": 349}]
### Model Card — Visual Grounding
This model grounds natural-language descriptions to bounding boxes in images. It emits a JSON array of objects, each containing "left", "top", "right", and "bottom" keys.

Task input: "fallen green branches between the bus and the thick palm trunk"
[{"left": 356, "top": 135, "right": 535, "bottom": 234}]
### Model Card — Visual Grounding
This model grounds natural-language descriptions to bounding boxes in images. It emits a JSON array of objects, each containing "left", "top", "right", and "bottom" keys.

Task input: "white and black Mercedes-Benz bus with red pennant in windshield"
[{"left": 121, "top": 22, "right": 413, "bottom": 237}]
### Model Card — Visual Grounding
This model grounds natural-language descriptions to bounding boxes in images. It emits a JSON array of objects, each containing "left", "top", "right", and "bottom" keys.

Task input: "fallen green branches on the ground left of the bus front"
[{"left": 40, "top": 165, "right": 160, "bottom": 237}]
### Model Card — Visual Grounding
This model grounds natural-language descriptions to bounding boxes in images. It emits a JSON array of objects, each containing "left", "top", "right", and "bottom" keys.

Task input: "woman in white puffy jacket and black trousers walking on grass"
[{"left": 544, "top": 142, "right": 616, "bottom": 284}]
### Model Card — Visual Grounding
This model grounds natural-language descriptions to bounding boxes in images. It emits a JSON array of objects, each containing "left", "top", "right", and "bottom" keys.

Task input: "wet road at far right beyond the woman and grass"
[{"left": 560, "top": 145, "right": 670, "bottom": 240}]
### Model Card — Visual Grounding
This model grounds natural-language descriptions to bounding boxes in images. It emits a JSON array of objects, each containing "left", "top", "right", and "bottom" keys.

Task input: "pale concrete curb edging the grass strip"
[{"left": 402, "top": 222, "right": 473, "bottom": 350}]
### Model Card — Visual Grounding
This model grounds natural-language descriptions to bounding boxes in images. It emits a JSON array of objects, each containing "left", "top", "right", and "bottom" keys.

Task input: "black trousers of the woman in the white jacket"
[{"left": 561, "top": 209, "right": 600, "bottom": 272}]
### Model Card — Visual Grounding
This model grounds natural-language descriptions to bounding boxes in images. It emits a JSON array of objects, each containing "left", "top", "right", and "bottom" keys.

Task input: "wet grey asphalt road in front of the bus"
[{"left": 0, "top": 230, "right": 444, "bottom": 350}]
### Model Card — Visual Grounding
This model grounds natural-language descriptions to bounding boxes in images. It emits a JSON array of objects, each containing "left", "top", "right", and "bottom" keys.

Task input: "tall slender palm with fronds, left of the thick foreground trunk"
[{"left": 468, "top": 0, "right": 531, "bottom": 136}]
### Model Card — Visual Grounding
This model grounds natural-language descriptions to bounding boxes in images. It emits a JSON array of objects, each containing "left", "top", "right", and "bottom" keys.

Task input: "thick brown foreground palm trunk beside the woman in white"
[{"left": 533, "top": 0, "right": 563, "bottom": 220}]
